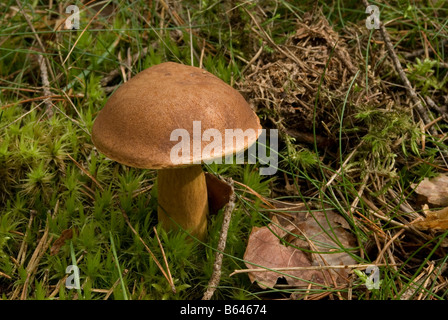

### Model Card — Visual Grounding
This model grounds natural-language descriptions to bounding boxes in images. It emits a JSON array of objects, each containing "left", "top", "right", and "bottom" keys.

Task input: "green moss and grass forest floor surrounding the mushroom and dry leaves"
[{"left": 0, "top": 0, "right": 448, "bottom": 300}]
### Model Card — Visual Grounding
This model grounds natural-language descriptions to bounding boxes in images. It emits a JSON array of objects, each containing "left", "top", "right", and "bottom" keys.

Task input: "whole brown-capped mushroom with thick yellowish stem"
[{"left": 92, "top": 62, "right": 261, "bottom": 240}]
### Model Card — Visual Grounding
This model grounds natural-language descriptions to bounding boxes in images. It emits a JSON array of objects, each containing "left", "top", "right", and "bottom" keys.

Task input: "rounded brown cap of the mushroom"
[{"left": 92, "top": 62, "right": 261, "bottom": 169}]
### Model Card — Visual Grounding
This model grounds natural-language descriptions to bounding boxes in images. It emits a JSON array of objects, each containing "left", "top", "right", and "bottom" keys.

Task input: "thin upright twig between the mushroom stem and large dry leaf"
[{"left": 202, "top": 178, "right": 235, "bottom": 300}]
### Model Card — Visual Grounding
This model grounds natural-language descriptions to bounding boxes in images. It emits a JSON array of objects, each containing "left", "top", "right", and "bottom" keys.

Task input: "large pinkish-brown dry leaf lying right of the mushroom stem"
[{"left": 244, "top": 204, "right": 356, "bottom": 288}]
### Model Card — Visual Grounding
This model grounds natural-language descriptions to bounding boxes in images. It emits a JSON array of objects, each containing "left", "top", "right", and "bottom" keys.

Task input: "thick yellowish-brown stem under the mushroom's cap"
[{"left": 157, "top": 165, "right": 208, "bottom": 240}]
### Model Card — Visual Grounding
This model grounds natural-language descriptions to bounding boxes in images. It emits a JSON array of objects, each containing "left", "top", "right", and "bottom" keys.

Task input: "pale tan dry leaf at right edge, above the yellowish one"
[{"left": 412, "top": 174, "right": 448, "bottom": 207}]
